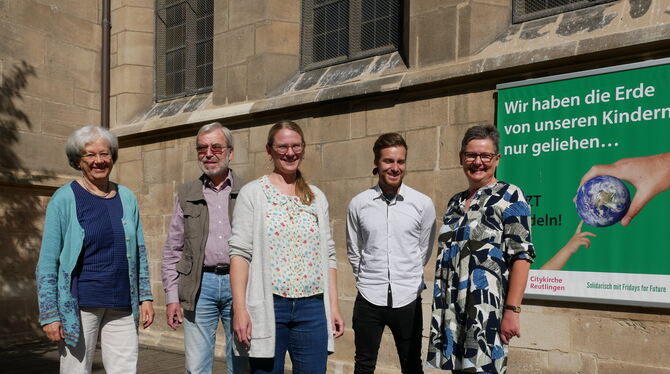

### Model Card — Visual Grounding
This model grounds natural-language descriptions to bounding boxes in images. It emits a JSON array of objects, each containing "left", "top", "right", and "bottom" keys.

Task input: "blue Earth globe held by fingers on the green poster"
[{"left": 575, "top": 175, "right": 630, "bottom": 227}]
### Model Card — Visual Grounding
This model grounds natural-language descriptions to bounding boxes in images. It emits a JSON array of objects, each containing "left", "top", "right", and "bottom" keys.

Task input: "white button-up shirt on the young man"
[{"left": 347, "top": 184, "right": 435, "bottom": 308}]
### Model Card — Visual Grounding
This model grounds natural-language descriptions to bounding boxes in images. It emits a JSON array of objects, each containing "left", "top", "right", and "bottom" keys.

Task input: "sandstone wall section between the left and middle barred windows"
[{"left": 213, "top": 0, "right": 300, "bottom": 105}]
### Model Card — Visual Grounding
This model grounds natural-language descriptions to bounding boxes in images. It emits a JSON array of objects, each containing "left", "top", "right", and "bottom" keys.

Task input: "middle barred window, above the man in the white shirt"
[{"left": 300, "top": 0, "right": 402, "bottom": 71}]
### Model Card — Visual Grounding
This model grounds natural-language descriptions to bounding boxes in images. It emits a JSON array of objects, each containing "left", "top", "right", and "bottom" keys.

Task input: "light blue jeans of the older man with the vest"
[{"left": 184, "top": 272, "right": 248, "bottom": 374}]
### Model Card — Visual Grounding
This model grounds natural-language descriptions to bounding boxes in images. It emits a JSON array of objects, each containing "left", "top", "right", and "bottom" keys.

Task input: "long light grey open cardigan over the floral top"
[{"left": 228, "top": 179, "right": 337, "bottom": 357}]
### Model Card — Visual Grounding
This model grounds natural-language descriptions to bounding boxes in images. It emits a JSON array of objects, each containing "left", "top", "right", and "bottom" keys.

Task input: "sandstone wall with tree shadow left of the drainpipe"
[{"left": 0, "top": 0, "right": 100, "bottom": 346}]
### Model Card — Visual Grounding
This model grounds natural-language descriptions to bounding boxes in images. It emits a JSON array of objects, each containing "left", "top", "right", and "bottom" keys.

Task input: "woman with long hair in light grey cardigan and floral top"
[{"left": 229, "top": 121, "right": 344, "bottom": 374}]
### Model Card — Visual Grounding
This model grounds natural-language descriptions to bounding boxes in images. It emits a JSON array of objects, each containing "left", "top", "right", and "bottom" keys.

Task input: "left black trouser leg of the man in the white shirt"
[{"left": 352, "top": 293, "right": 387, "bottom": 374}]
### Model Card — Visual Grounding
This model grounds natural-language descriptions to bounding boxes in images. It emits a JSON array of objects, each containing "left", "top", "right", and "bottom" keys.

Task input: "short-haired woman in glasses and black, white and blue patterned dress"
[{"left": 427, "top": 126, "right": 535, "bottom": 373}]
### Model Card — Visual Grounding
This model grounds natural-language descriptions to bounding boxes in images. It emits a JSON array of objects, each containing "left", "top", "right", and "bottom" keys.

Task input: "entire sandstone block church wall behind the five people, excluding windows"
[{"left": 0, "top": 0, "right": 670, "bottom": 374}]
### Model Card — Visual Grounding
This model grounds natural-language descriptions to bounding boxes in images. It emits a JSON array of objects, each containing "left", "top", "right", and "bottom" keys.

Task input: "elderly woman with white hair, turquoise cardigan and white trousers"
[{"left": 36, "top": 126, "right": 154, "bottom": 374}]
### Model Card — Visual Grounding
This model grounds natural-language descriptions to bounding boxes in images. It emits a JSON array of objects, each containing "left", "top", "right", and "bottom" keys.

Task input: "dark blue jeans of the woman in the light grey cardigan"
[{"left": 249, "top": 294, "right": 328, "bottom": 374}]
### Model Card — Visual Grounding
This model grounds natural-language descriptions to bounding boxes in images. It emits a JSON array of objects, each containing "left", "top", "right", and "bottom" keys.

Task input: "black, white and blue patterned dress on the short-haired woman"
[{"left": 427, "top": 182, "right": 535, "bottom": 373}]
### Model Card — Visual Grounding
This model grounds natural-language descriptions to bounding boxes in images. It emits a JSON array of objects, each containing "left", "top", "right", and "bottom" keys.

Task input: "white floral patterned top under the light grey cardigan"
[{"left": 261, "top": 175, "right": 323, "bottom": 298}]
